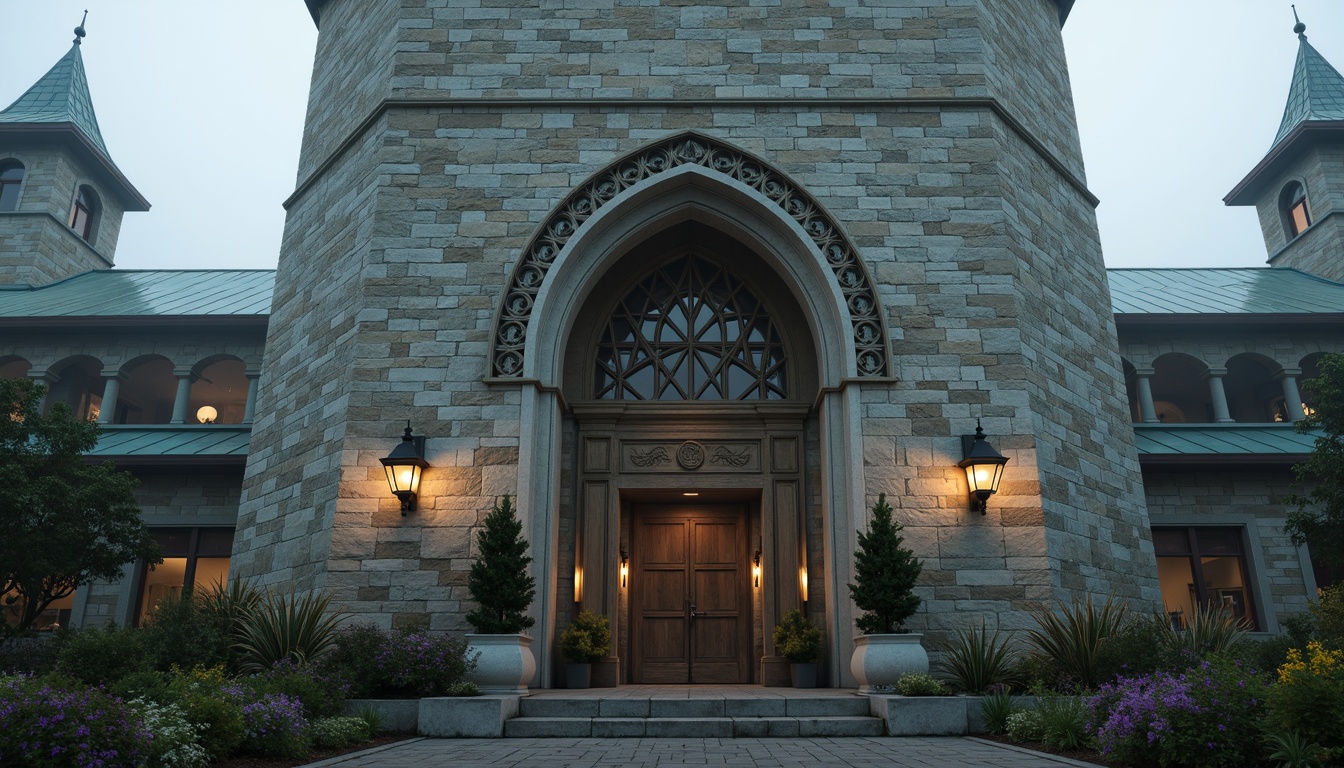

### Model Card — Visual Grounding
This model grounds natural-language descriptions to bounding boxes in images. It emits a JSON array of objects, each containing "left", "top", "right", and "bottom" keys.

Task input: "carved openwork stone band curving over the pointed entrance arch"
[{"left": 492, "top": 135, "right": 890, "bottom": 378}]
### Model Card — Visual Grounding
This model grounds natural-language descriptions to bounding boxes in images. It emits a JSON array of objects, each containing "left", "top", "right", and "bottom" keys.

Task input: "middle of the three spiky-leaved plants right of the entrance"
[{"left": 1027, "top": 594, "right": 1129, "bottom": 689}]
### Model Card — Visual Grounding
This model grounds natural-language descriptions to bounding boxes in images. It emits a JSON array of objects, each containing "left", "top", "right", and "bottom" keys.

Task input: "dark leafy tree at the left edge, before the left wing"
[{"left": 0, "top": 379, "right": 163, "bottom": 636}]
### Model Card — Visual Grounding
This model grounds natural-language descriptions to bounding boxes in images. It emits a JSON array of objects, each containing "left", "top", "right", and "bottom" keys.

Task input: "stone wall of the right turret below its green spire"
[{"left": 1255, "top": 143, "right": 1344, "bottom": 281}]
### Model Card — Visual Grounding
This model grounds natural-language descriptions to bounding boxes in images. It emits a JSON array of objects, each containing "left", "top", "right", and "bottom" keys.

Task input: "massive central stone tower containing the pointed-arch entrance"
[{"left": 234, "top": 0, "right": 1157, "bottom": 686}]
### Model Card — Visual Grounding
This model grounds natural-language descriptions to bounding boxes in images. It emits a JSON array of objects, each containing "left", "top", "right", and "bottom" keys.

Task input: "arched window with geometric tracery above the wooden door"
[{"left": 593, "top": 256, "right": 788, "bottom": 401}]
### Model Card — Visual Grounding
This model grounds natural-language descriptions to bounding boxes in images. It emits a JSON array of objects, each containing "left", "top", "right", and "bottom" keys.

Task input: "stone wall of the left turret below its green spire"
[{"left": 0, "top": 144, "right": 122, "bottom": 285}]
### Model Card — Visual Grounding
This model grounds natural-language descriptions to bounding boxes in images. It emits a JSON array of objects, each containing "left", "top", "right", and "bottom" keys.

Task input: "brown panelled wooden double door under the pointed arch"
[{"left": 630, "top": 504, "right": 751, "bottom": 685}]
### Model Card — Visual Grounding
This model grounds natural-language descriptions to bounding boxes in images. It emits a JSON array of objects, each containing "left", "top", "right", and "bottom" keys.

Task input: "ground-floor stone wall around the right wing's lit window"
[{"left": 1144, "top": 468, "right": 1316, "bottom": 632}]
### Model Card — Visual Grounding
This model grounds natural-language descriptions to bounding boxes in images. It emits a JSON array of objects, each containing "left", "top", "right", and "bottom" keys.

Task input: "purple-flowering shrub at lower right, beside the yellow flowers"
[{"left": 1090, "top": 659, "right": 1269, "bottom": 765}]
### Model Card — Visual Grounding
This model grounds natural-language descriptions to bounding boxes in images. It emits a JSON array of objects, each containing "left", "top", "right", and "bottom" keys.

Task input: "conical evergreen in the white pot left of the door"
[{"left": 466, "top": 496, "right": 536, "bottom": 635}]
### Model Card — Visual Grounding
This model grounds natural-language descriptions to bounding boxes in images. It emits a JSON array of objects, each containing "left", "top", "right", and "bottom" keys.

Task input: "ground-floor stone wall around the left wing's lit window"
[{"left": 74, "top": 469, "right": 242, "bottom": 627}]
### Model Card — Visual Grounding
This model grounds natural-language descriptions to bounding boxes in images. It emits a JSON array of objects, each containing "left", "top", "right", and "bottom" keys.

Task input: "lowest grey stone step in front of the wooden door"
[{"left": 504, "top": 715, "right": 882, "bottom": 738}]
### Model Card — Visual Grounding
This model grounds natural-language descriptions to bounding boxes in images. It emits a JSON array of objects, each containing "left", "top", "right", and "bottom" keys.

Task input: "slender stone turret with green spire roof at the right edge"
[{"left": 1223, "top": 22, "right": 1344, "bottom": 281}]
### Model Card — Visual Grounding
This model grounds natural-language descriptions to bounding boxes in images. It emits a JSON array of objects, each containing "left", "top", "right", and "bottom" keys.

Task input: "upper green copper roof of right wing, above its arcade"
[{"left": 1106, "top": 266, "right": 1344, "bottom": 315}]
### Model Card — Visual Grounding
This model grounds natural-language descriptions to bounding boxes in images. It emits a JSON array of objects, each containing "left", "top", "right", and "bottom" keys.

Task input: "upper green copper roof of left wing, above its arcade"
[{"left": 0, "top": 269, "right": 276, "bottom": 319}]
